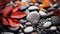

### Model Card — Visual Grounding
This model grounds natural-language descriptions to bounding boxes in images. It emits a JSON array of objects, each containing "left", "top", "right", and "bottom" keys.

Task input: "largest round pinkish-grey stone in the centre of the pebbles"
[{"left": 26, "top": 12, "right": 40, "bottom": 22}]
